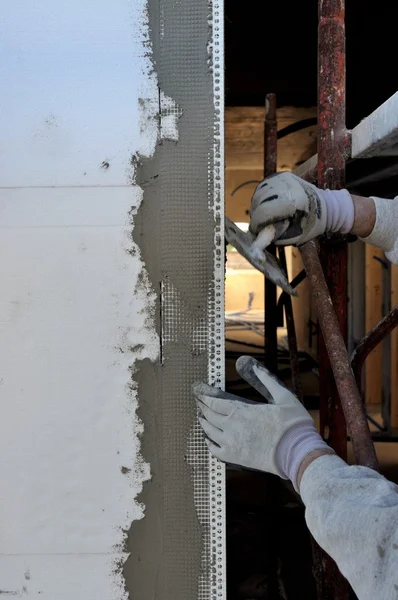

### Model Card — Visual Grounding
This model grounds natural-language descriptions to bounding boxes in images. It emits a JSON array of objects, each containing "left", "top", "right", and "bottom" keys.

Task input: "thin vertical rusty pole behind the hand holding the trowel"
[{"left": 264, "top": 94, "right": 278, "bottom": 374}]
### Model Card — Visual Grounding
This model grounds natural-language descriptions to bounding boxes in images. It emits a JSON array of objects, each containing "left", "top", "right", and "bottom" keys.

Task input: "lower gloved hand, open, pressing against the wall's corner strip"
[{"left": 193, "top": 356, "right": 330, "bottom": 490}]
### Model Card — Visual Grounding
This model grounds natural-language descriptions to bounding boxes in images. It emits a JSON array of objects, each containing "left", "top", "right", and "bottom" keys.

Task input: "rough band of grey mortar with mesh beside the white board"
[{"left": 124, "top": 0, "right": 215, "bottom": 600}]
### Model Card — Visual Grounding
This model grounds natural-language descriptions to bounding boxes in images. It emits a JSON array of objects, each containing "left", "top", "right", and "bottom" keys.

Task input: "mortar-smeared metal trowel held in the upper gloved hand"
[{"left": 225, "top": 217, "right": 298, "bottom": 296}]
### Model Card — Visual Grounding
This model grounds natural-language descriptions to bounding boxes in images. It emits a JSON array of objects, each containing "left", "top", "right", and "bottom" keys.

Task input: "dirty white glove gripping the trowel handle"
[{"left": 250, "top": 172, "right": 354, "bottom": 245}]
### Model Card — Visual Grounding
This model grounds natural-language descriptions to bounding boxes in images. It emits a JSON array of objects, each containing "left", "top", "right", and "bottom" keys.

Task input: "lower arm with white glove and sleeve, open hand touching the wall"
[{"left": 194, "top": 357, "right": 398, "bottom": 600}]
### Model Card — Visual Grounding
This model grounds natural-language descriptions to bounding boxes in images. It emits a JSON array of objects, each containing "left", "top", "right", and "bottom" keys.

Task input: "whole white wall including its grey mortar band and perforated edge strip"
[{"left": 0, "top": 0, "right": 225, "bottom": 600}]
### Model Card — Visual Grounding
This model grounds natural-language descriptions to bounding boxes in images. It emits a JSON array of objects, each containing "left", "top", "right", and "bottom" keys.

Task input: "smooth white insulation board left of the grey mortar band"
[{"left": 0, "top": 0, "right": 224, "bottom": 600}]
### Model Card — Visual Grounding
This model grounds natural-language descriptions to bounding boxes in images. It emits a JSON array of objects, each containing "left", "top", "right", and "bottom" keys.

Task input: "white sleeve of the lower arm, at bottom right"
[{"left": 300, "top": 455, "right": 398, "bottom": 600}]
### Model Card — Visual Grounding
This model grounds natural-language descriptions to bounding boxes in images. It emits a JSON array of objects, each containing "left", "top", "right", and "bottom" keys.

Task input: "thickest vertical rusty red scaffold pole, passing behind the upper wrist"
[{"left": 314, "top": 0, "right": 347, "bottom": 459}]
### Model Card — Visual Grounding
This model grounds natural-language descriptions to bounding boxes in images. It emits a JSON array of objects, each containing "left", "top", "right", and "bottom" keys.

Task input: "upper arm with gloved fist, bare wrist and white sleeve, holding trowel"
[{"left": 250, "top": 173, "right": 398, "bottom": 264}]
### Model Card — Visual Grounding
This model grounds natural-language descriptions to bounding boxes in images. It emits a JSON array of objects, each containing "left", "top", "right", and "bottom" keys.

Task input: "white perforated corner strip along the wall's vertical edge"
[{"left": 188, "top": 0, "right": 226, "bottom": 600}]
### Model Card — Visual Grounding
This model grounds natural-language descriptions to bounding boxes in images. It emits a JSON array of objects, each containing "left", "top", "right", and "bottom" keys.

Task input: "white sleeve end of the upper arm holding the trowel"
[{"left": 362, "top": 197, "right": 398, "bottom": 265}]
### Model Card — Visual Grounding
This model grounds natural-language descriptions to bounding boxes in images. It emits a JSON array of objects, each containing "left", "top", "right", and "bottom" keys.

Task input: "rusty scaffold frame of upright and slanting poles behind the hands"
[{"left": 264, "top": 0, "right": 398, "bottom": 600}]
